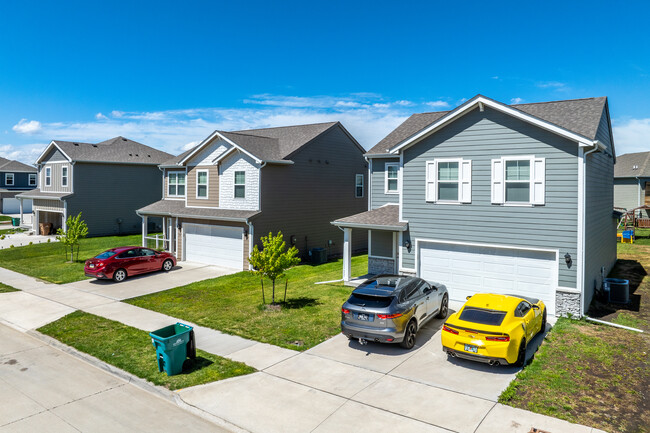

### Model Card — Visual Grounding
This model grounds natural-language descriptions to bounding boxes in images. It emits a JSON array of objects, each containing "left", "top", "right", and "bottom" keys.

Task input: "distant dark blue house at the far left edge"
[{"left": 0, "top": 157, "right": 37, "bottom": 214}]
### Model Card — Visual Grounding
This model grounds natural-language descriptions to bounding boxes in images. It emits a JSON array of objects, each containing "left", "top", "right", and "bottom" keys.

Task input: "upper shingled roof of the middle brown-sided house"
[{"left": 172, "top": 122, "right": 364, "bottom": 167}]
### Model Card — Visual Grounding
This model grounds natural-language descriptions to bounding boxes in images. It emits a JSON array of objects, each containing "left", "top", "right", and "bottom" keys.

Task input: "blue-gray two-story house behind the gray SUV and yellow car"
[{"left": 332, "top": 95, "right": 616, "bottom": 316}]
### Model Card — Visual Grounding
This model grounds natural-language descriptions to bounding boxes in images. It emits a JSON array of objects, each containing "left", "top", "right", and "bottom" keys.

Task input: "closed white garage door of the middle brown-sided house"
[{"left": 183, "top": 224, "right": 244, "bottom": 270}]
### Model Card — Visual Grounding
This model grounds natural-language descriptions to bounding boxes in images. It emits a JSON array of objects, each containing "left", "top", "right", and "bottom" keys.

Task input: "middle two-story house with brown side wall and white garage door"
[{"left": 137, "top": 122, "right": 368, "bottom": 270}]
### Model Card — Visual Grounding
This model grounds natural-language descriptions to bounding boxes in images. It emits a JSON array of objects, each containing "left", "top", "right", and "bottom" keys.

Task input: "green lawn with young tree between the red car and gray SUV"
[{"left": 125, "top": 255, "right": 368, "bottom": 350}]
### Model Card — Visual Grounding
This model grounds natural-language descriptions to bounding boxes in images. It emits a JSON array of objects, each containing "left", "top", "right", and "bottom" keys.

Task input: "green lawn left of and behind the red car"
[{"left": 0, "top": 235, "right": 142, "bottom": 284}]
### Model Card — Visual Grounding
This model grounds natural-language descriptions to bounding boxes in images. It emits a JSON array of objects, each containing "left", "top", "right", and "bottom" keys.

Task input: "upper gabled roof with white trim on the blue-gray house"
[{"left": 367, "top": 95, "right": 607, "bottom": 156}]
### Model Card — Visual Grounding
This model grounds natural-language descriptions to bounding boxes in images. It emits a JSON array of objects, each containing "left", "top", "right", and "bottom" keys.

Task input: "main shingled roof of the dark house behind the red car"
[{"left": 36, "top": 137, "right": 172, "bottom": 165}]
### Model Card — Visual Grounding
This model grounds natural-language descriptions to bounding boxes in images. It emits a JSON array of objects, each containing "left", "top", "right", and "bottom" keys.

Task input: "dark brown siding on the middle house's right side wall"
[{"left": 253, "top": 126, "right": 368, "bottom": 259}]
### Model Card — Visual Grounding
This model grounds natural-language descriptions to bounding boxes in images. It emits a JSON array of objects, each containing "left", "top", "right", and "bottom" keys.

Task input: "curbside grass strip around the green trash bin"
[{"left": 38, "top": 311, "right": 256, "bottom": 390}]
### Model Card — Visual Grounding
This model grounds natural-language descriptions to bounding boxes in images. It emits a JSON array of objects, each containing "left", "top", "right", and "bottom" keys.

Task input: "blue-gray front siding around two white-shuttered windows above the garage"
[{"left": 400, "top": 108, "right": 578, "bottom": 288}]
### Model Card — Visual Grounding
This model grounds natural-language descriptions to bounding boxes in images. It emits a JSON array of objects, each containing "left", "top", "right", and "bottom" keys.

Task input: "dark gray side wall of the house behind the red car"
[{"left": 67, "top": 162, "right": 162, "bottom": 236}]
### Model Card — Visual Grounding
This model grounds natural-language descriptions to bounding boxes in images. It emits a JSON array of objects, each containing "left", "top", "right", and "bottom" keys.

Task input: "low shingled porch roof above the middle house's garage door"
[{"left": 136, "top": 200, "right": 259, "bottom": 222}]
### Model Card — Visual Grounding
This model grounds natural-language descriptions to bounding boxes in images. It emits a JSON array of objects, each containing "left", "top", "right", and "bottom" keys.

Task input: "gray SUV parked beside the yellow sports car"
[{"left": 341, "top": 275, "right": 449, "bottom": 349}]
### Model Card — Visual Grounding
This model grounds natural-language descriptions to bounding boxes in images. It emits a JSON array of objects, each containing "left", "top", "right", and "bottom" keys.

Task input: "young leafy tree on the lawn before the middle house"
[{"left": 249, "top": 232, "right": 300, "bottom": 304}]
